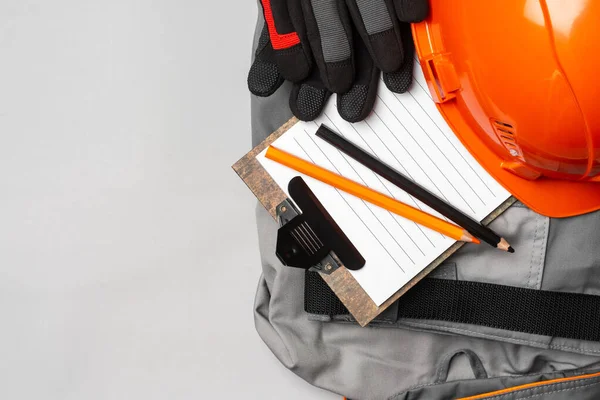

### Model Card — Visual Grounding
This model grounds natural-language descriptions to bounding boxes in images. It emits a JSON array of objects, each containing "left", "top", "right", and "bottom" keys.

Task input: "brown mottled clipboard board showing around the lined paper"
[{"left": 233, "top": 118, "right": 517, "bottom": 327}]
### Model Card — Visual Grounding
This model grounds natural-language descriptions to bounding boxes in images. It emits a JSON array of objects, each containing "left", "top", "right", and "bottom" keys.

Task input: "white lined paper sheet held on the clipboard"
[{"left": 257, "top": 63, "right": 510, "bottom": 306}]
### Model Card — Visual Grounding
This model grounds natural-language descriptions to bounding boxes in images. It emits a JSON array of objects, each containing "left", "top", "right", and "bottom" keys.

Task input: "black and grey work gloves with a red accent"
[{"left": 248, "top": 0, "right": 429, "bottom": 122}]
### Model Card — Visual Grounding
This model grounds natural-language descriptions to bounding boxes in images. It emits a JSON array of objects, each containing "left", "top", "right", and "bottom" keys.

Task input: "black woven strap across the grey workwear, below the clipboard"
[{"left": 304, "top": 272, "right": 600, "bottom": 341}]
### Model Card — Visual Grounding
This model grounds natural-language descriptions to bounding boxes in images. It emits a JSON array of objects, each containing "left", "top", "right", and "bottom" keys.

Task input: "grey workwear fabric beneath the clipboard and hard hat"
[{"left": 252, "top": 14, "right": 600, "bottom": 400}]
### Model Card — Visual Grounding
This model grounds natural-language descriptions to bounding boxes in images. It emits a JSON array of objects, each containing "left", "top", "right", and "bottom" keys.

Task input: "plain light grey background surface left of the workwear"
[{"left": 0, "top": 0, "right": 339, "bottom": 400}]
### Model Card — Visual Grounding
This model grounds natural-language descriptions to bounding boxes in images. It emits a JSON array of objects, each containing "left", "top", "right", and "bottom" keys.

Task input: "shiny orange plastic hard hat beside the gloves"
[{"left": 413, "top": 0, "right": 600, "bottom": 217}]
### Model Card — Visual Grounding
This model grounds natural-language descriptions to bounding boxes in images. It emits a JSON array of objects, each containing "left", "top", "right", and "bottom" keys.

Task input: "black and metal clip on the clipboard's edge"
[{"left": 276, "top": 176, "right": 365, "bottom": 275}]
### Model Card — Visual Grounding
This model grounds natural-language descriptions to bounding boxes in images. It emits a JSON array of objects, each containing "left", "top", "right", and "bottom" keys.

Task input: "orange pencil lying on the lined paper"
[{"left": 265, "top": 146, "right": 480, "bottom": 244}]
